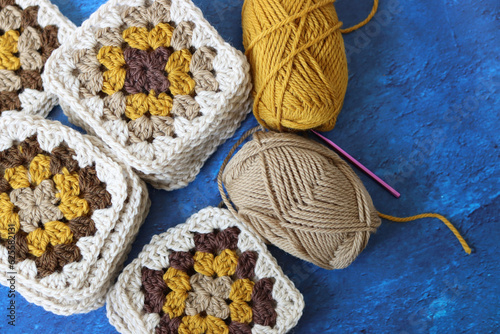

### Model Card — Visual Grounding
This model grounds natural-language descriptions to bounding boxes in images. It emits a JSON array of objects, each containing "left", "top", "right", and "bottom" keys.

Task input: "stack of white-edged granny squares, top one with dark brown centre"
[{"left": 44, "top": 0, "right": 251, "bottom": 190}]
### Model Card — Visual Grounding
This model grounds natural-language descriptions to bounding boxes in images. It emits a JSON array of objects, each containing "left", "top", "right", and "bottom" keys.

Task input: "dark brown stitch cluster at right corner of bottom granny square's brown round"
[{"left": 252, "top": 278, "right": 278, "bottom": 327}]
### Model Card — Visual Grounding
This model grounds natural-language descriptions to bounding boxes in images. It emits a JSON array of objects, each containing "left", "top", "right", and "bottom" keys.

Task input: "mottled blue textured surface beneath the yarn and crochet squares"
[{"left": 0, "top": 0, "right": 500, "bottom": 333}]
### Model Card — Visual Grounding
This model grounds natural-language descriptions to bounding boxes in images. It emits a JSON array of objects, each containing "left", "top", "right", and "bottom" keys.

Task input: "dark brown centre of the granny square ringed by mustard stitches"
[{"left": 124, "top": 47, "right": 172, "bottom": 94}]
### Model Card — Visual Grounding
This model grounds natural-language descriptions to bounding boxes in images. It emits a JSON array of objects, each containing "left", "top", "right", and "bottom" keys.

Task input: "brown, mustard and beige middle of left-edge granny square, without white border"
[{"left": 0, "top": 135, "right": 111, "bottom": 278}]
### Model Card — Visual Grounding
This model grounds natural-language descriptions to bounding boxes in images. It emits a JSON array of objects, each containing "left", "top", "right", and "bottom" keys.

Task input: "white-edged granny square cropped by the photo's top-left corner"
[{"left": 0, "top": 0, "right": 76, "bottom": 116}]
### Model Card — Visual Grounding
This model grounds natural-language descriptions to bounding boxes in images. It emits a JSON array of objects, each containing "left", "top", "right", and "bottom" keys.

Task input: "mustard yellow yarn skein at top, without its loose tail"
[{"left": 242, "top": 0, "right": 348, "bottom": 131}]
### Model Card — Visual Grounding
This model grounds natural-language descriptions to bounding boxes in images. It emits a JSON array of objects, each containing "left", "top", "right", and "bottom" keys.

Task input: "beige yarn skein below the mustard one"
[{"left": 219, "top": 132, "right": 381, "bottom": 269}]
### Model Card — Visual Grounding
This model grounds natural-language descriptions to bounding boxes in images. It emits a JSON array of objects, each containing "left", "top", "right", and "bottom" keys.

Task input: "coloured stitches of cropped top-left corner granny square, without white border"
[{"left": 0, "top": 0, "right": 59, "bottom": 114}]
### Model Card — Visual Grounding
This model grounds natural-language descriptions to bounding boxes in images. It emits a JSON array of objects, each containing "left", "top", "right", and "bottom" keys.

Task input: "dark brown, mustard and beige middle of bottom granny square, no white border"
[{"left": 141, "top": 227, "right": 277, "bottom": 334}]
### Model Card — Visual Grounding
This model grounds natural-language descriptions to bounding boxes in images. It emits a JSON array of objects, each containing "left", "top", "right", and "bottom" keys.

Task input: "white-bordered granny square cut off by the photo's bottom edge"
[{"left": 106, "top": 207, "right": 304, "bottom": 334}]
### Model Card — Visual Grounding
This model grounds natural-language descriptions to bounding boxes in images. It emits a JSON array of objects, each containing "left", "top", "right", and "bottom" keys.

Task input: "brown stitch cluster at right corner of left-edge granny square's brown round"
[{"left": 78, "top": 166, "right": 111, "bottom": 210}]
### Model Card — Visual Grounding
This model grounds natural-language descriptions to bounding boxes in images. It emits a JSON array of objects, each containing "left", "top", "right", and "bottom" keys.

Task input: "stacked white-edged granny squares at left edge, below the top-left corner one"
[{"left": 0, "top": 113, "right": 149, "bottom": 315}]
